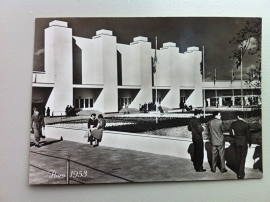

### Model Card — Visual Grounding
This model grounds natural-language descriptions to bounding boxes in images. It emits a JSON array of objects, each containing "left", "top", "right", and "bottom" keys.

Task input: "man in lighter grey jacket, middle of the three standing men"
[{"left": 207, "top": 111, "right": 227, "bottom": 173}]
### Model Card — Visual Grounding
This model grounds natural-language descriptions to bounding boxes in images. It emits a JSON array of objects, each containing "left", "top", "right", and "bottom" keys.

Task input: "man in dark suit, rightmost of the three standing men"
[{"left": 231, "top": 112, "right": 251, "bottom": 179}]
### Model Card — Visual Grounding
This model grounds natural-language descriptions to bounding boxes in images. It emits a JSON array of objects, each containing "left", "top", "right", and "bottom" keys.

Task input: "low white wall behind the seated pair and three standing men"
[{"left": 45, "top": 125, "right": 261, "bottom": 168}]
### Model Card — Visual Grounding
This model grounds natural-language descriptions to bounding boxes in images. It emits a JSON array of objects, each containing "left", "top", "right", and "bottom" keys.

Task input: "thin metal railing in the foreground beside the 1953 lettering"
[{"left": 29, "top": 151, "right": 134, "bottom": 184}]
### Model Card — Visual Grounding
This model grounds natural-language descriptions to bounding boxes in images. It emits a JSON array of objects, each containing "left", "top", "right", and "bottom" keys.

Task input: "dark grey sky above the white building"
[{"left": 34, "top": 17, "right": 259, "bottom": 80}]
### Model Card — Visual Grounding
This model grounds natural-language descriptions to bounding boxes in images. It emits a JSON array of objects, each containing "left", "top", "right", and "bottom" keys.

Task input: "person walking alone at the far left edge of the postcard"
[{"left": 31, "top": 108, "right": 45, "bottom": 147}]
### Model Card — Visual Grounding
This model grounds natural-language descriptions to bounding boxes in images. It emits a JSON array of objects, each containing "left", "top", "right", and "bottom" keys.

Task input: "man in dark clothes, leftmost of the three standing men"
[{"left": 188, "top": 109, "right": 206, "bottom": 172}]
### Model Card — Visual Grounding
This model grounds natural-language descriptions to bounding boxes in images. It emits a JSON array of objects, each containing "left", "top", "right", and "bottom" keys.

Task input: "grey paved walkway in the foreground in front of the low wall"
[{"left": 29, "top": 136, "right": 262, "bottom": 184}]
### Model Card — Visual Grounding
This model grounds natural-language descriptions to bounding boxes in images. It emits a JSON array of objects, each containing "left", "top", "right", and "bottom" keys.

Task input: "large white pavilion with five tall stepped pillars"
[{"left": 32, "top": 20, "right": 256, "bottom": 115}]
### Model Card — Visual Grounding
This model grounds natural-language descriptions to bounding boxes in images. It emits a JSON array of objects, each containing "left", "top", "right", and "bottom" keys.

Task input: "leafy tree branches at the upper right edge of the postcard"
[{"left": 229, "top": 19, "right": 262, "bottom": 110}]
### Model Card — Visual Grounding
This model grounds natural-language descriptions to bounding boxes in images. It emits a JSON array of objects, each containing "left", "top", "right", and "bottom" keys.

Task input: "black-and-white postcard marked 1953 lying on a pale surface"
[{"left": 29, "top": 16, "right": 263, "bottom": 185}]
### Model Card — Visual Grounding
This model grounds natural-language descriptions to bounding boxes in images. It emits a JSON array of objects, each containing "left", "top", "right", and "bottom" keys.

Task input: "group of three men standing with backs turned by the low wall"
[{"left": 188, "top": 110, "right": 251, "bottom": 179}]
